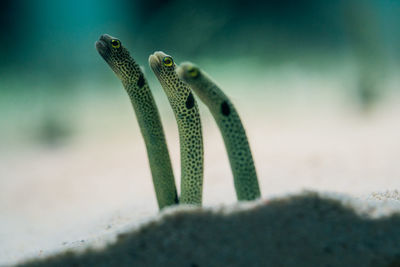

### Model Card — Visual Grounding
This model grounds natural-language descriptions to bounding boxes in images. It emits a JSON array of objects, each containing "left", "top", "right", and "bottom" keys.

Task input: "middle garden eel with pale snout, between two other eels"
[{"left": 149, "top": 52, "right": 204, "bottom": 205}]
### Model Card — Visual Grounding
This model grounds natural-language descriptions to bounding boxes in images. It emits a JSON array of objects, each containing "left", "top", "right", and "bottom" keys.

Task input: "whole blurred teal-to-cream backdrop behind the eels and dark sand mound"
[{"left": 0, "top": 0, "right": 400, "bottom": 265}]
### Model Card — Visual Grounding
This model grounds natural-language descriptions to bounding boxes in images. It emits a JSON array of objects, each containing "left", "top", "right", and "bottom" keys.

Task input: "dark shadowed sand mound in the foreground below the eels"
[{"left": 19, "top": 192, "right": 400, "bottom": 267}]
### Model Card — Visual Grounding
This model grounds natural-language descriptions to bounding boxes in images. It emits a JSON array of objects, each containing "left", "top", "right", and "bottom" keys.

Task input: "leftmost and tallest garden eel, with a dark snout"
[{"left": 96, "top": 34, "right": 178, "bottom": 209}]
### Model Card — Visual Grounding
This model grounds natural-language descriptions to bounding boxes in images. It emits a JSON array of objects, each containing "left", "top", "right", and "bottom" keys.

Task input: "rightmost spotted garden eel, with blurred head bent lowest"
[{"left": 177, "top": 63, "right": 260, "bottom": 200}]
